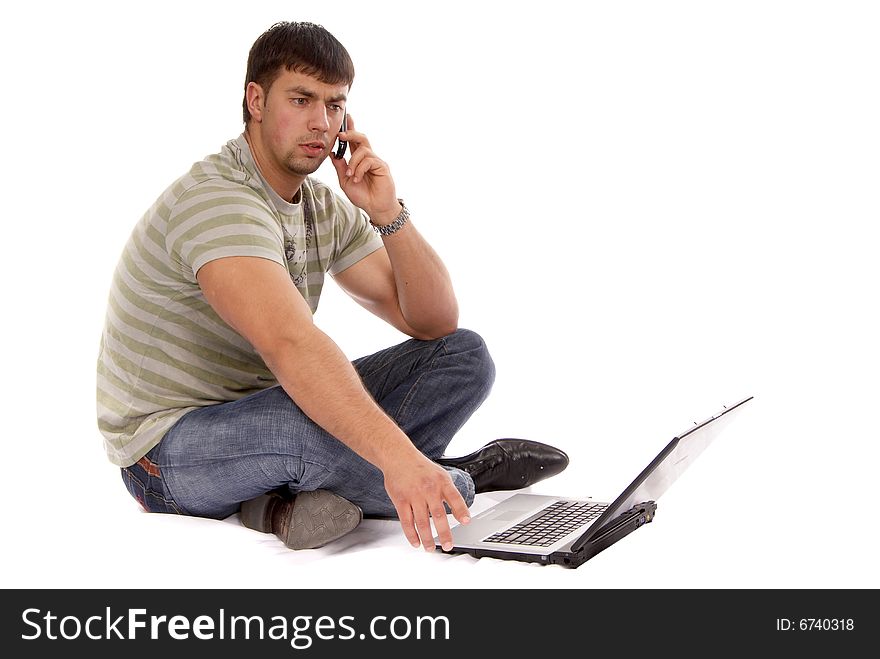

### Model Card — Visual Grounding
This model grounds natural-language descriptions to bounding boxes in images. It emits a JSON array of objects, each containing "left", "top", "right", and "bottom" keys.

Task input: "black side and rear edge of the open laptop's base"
[{"left": 438, "top": 501, "right": 657, "bottom": 568}]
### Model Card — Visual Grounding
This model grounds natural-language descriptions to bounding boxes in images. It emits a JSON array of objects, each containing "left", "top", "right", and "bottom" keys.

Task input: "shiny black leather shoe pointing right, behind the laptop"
[{"left": 436, "top": 439, "right": 568, "bottom": 494}]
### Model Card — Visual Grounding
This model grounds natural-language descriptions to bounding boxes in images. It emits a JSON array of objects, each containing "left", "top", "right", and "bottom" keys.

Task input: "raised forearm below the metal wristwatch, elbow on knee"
[{"left": 383, "top": 213, "right": 458, "bottom": 338}]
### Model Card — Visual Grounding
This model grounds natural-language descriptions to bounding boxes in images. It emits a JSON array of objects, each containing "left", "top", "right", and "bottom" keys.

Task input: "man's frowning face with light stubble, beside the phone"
[{"left": 248, "top": 70, "right": 348, "bottom": 179}]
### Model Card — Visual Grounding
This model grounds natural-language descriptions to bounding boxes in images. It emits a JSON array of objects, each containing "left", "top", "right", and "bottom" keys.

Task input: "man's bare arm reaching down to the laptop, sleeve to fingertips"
[{"left": 196, "top": 257, "right": 468, "bottom": 551}]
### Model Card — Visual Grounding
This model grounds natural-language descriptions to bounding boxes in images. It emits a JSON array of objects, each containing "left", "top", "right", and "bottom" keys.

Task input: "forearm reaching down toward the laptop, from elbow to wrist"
[{"left": 262, "top": 327, "right": 416, "bottom": 471}]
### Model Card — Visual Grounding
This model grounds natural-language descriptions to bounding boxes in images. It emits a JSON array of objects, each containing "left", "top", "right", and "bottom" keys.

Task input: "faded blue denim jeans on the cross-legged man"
[{"left": 122, "top": 329, "right": 495, "bottom": 519}]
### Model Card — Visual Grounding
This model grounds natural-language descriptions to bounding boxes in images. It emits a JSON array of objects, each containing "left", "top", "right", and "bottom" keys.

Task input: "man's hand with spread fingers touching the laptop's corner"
[{"left": 384, "top": 453, "right": 470, "bottom": 551}]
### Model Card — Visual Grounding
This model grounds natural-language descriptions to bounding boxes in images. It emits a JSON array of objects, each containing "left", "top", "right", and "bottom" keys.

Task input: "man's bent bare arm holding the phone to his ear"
[{"left": 331, "top": 116, "right": 458, "bottom": 339}]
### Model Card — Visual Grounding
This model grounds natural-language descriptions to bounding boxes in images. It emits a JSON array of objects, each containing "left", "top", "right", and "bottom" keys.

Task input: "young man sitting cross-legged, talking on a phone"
[{"left": 97, "top": 23, "right": 568, "bottom": 550}]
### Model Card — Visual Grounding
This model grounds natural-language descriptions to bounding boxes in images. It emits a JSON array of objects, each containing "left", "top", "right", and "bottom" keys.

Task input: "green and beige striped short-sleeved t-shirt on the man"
[{"left": 97, "top": 134, "right": 382, "bottom": 467}]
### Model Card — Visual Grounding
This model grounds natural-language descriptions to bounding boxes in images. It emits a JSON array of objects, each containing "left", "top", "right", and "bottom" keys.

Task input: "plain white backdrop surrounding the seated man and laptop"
[{"left": 0, "top": 0, "right": 880, "bottom": 588}]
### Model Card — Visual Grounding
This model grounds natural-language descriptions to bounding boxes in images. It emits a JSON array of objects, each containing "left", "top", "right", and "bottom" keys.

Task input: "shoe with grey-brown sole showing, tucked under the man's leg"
[{"left": 240, "top": 490, "right": 364, "bottom": 549}]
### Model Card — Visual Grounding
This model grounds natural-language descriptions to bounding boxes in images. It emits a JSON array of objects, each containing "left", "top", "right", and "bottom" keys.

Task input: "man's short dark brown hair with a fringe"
[{"left": 241, "top": 21, "right": 354, "bottom": 123}]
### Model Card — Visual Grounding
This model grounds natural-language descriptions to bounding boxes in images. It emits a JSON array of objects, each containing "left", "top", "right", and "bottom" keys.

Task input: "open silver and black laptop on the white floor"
[{"left": 434, "top": 396, "right": 753, "bottom": 568}]
